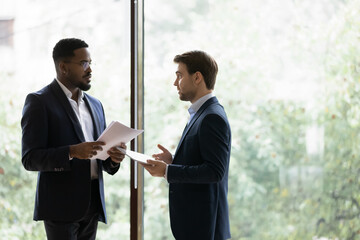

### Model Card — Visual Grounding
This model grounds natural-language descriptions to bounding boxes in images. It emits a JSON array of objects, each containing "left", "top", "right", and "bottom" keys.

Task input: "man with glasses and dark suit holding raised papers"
[{"left": 21, "top": 38, "right": 126, "bottom": 240}]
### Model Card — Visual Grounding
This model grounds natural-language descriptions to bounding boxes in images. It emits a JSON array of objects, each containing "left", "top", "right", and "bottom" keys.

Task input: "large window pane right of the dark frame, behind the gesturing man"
[{"left": 144, "top": 0, "right": 360, "bottom": 240}]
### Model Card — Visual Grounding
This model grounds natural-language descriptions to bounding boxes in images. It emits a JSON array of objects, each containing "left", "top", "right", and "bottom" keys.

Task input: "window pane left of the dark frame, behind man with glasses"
[{"left": 0, "top": 0, "right": 130, "bottom": 239}]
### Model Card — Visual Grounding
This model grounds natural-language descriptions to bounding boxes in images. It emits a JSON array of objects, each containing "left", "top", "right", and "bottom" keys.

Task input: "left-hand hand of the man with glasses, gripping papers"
[{"left": 69, "top": 142, "right": 105, "bottom": 159}]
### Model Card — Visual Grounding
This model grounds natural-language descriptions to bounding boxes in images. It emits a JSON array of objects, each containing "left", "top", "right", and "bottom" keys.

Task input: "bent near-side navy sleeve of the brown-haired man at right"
[{"left": 167, "top": 114, "right": 231, "bottom": 183}]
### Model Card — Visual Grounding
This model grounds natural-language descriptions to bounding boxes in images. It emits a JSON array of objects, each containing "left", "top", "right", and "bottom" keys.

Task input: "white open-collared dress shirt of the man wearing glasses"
[{"left": 56, "top": 79, "right": 98, "bottom": 179}]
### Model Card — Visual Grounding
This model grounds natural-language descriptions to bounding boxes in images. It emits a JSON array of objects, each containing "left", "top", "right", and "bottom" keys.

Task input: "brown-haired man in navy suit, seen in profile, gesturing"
[{"left": 143, "top": 51, "right": 231, "bottom": 240}]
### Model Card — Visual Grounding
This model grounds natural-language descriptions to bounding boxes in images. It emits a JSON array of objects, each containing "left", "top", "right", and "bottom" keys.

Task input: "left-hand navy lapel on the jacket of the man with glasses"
[{"left": 50, "top": 80, "right": 85, "bottom": 142}]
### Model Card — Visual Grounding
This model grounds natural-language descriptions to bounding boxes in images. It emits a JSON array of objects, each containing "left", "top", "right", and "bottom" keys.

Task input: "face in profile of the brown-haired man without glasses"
[{"left": 174, "top": 63, "right": 197, "bottom": 102}]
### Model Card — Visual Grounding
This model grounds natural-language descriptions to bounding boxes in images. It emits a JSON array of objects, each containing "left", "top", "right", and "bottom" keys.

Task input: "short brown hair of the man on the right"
[{"left": 174, "top": 50, "right": 218, "bottom": 90}]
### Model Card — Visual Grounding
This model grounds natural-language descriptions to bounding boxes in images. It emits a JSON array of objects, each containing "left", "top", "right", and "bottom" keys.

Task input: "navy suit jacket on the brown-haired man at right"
[{"left": 167, "top": 97, "right": 231, "bottom": 240}]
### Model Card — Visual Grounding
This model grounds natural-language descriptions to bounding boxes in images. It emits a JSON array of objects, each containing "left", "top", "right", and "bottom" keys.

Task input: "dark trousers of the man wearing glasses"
[{"left": 44, "top": 179, "right": 101, "bottom": 240}]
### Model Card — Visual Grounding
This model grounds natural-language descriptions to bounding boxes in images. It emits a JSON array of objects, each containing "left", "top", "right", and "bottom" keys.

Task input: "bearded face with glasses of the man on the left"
[{"left": 64, "top": 48, "right": 92, "bottom": 91}]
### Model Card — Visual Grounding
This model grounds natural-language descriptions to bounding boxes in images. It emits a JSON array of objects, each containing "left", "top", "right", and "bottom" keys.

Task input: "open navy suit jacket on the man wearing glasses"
[{"left": 21, "top": 80, "right": 119, "bottom": 223}]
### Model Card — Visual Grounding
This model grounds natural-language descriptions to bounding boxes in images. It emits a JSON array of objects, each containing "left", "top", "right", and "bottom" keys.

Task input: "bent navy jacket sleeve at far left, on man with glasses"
[{"left": 21, "top": 94, "right": 70, "bottom": 171}]
